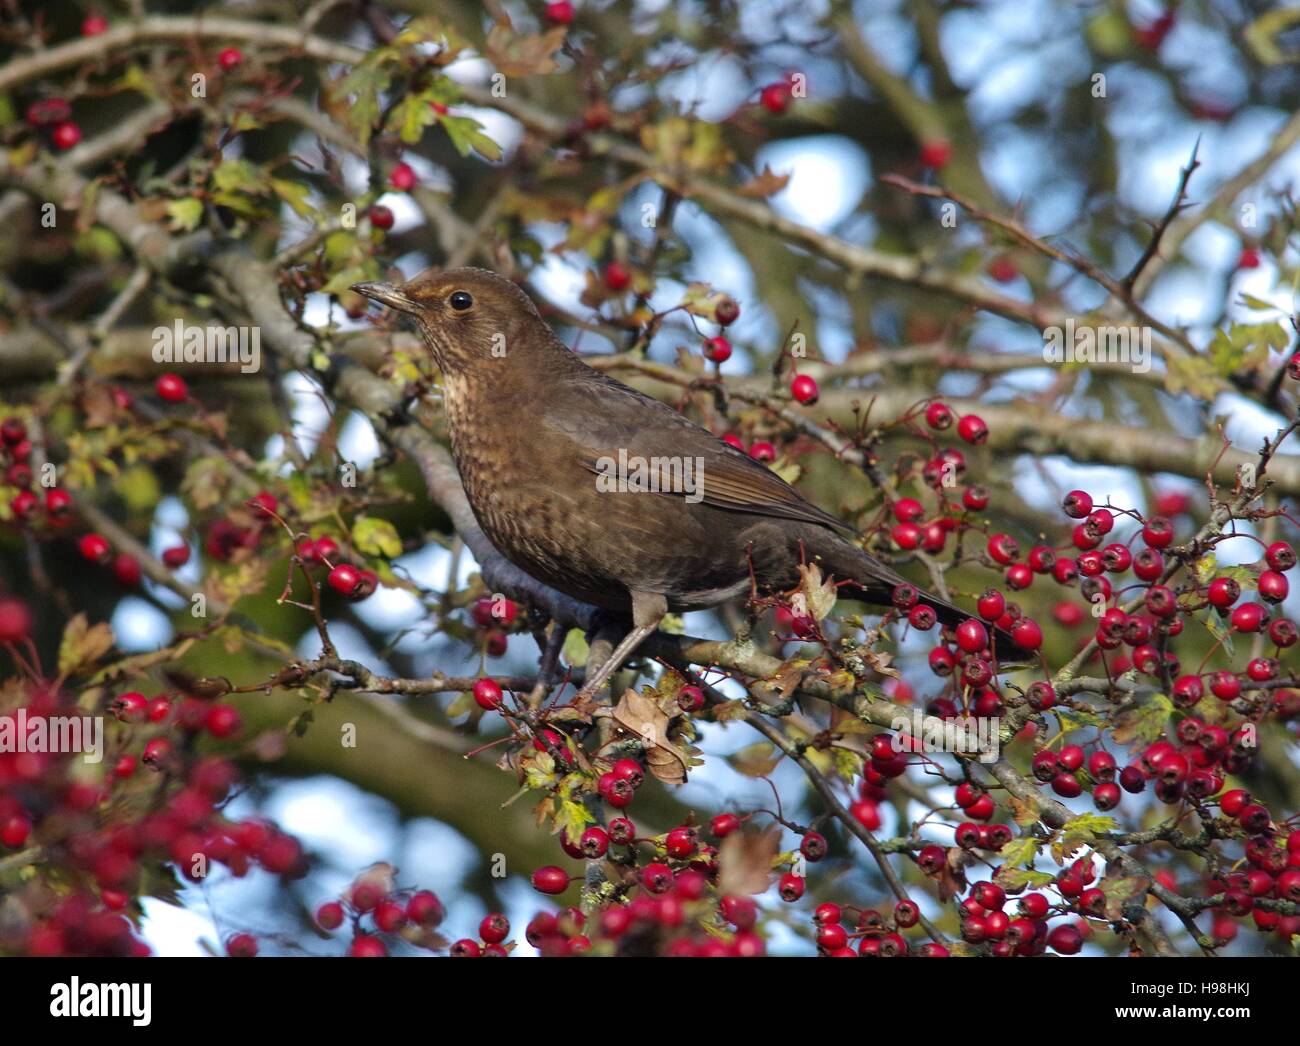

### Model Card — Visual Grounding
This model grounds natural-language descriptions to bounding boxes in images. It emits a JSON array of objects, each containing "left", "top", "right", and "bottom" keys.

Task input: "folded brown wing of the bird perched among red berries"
[{"left": 543, "top": 368, "right": 853, "bottom": 530}]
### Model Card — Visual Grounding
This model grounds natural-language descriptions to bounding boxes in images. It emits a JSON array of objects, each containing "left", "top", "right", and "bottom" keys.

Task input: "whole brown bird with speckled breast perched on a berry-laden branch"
[{"left": 352, "top": 268, "right": 1023, "bottom": 696}]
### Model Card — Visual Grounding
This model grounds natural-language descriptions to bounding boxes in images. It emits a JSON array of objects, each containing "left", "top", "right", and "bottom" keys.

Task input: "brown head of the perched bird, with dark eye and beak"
[{"left": 352, "top": 268, "right": 558, "bottom": 373}]
